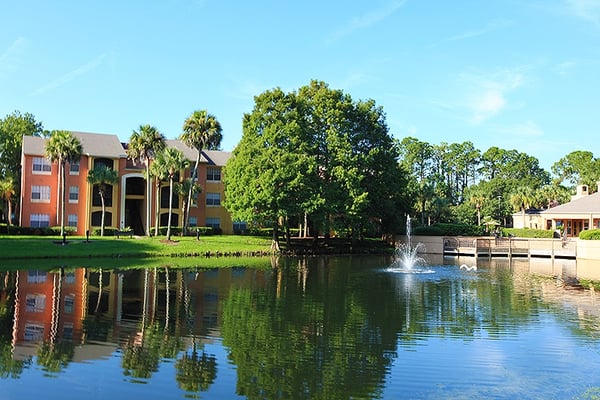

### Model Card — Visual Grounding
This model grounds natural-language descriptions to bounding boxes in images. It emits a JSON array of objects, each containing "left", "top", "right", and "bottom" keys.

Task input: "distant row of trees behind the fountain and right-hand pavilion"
[{"left": 399, "top": 137, "right": 600, "bottom": 231}]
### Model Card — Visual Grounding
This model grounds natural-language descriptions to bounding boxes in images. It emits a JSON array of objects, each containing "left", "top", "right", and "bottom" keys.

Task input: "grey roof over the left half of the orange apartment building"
[{"left": 23, "top": 132, "right": 127, "bottom": 158}]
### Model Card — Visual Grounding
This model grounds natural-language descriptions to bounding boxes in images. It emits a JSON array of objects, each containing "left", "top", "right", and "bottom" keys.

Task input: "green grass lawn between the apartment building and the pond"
[{"left": 0, "top": 235, "right": 271, "bottom": 265}]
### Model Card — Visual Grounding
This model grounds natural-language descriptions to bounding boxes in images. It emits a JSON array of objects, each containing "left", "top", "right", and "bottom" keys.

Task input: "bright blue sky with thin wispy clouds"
[{"left": 0, "top": 0, "right": 600, "bottom": 170}]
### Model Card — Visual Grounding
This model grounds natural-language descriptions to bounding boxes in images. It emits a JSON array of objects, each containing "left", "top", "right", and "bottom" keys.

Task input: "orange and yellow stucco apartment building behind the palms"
[{"left": 20, "top": 132, "right": 237, "bottom": 235}]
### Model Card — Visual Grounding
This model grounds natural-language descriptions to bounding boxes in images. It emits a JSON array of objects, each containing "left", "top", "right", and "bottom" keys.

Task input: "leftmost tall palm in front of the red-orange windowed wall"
[{"left": 45, "top": 131, "right": 83, "bottom": 236}]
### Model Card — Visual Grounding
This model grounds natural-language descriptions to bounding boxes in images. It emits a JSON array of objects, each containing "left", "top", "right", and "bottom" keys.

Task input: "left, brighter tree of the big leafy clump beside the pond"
[{"left": 223, "top": 88, "right": 310, "bottom": 248}]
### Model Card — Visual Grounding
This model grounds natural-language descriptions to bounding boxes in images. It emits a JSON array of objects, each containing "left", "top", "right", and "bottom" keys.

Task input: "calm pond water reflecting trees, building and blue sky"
[{"left": 0, "top": 257, "right": 600, "bottom": 400}]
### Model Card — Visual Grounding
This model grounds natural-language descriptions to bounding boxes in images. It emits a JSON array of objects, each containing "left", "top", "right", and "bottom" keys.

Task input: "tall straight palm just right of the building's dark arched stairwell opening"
[{"left": 127, "top": 124, "right": 165, "bottom": 236}]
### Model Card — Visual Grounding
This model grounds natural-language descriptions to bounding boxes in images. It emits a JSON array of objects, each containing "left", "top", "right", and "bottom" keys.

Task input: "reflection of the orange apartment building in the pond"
[{"left": 7, "top": 267, "right": 268, "bottom": 361}]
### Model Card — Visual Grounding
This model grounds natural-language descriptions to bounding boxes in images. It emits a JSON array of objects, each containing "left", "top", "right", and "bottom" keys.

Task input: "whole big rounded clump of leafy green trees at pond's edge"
[{"left": 224, "top": 81, "right": 405, "bottom": 247}]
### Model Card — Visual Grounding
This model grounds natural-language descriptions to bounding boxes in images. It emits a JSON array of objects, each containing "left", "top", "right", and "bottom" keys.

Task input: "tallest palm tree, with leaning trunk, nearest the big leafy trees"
[{"left": 179, "top": 110, "right": 223, "bottom": 233}]
